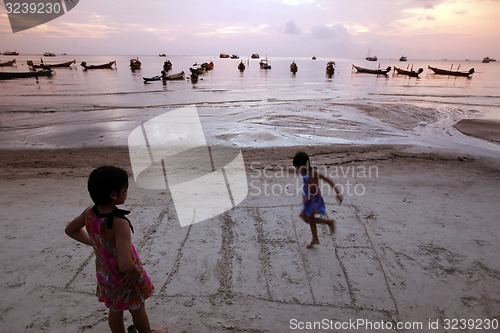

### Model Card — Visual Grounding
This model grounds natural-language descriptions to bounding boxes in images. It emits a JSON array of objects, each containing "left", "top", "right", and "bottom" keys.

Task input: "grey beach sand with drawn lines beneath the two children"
[{"left": 0, "top": 139, "right": 500, "bottom": 333}]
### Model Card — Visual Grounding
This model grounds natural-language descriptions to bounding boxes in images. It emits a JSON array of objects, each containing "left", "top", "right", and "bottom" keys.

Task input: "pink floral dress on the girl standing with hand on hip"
[{"left": 85, "top": 206, "right": 154, "bottom": 311}]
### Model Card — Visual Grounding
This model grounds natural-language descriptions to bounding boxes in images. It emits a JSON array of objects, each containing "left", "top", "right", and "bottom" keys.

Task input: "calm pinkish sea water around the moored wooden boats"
[{"left": 0, "top": 55, "right": 500, "bottom": 149}]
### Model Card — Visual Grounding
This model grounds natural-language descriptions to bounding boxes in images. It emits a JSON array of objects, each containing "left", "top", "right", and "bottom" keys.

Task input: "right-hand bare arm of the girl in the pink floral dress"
[{"left": 113, "top": 217, "right": 142, "bottom": 288}]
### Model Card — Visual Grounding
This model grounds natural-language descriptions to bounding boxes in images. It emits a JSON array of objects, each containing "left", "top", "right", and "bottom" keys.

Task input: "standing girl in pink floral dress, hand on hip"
[{"left": 65, "top": 166, "right": 167, "bottom": 333}]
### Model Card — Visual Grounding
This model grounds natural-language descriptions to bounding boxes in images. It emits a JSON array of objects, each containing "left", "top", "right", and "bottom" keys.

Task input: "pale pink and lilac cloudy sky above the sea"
[{"left": 0, "top": 0, "right": 500, "bottom": 60}]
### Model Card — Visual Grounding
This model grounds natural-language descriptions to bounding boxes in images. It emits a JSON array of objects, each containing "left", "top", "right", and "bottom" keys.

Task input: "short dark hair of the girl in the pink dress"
[{"left": 87, "top": 165, "right": 128, "bottom": 205}]
